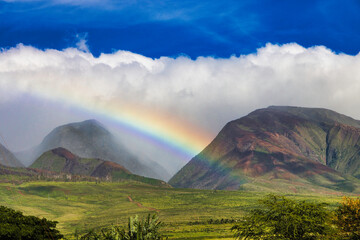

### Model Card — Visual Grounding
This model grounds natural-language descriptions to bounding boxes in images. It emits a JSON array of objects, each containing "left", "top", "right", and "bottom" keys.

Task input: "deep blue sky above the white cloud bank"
[{"left": 0, "top": 0, "right": 360, "bottom": 58}]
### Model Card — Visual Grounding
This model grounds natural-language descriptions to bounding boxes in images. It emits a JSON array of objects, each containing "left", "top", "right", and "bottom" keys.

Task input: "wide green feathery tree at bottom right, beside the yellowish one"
[{"left": 232, "top": 195, "right": 330, "bottom": 240}]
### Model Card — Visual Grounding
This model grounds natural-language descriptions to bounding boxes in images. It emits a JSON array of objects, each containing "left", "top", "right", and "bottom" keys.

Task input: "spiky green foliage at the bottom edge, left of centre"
[{"left": 78, "top": 214, "right": 164, "bottom": 240}]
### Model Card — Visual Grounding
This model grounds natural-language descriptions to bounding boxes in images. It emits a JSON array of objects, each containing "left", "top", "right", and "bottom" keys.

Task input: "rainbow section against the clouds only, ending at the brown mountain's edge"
[{"left": 32, "top": 89, "right": 211, "bottom": 160}]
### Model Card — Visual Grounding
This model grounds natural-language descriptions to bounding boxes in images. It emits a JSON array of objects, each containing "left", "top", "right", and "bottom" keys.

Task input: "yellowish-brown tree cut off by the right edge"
[{"left": 335, "top": 197, "right": 360, "bottom": 239}]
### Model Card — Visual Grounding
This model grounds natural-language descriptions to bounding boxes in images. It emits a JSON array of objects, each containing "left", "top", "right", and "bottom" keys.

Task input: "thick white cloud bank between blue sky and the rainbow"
[{"left": 0, "top": 43, "right": 360, "bottom": 154}]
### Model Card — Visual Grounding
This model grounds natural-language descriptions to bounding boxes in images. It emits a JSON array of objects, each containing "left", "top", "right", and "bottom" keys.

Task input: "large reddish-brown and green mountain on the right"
[{"left": 169, "top": 106, "right": 360, "bottom": 191}]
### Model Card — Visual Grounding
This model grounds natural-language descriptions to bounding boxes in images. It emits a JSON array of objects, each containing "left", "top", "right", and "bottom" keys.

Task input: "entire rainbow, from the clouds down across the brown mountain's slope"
[{"left": 7, "top": 68, "right": 245, "bottom": 188}]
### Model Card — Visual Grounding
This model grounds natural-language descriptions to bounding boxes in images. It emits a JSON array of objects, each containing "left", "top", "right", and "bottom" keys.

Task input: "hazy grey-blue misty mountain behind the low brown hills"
[{"left": 17, "top": 120, "right": 169, "bottom": 179}]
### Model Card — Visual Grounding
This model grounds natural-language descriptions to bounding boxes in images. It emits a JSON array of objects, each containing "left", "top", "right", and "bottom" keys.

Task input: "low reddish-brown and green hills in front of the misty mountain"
[{"left": 30, "top": 148, "right": 167, "bottom": 186}]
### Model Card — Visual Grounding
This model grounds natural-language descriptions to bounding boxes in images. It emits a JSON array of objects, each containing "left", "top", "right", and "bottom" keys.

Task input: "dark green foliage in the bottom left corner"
[{"left": 0, "top": 206, "right": 63, "bottom": 240}]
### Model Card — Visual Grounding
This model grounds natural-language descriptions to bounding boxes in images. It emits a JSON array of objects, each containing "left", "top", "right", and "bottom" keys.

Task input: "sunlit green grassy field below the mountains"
[{"left": 0, "top": 182, "right": 348, "bottom": 239}]
